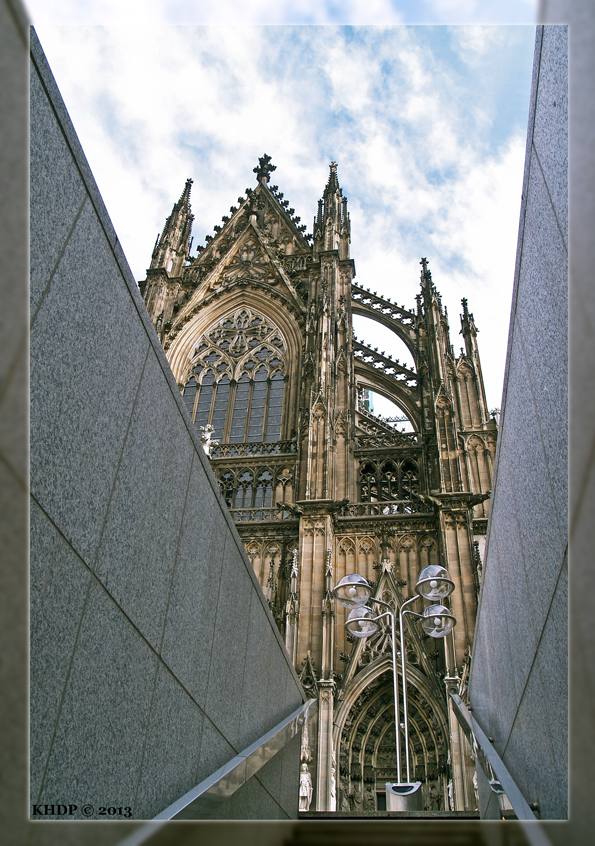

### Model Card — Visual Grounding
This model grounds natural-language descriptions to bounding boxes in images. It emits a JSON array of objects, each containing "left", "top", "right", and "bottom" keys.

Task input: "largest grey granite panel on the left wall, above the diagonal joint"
[{"left": 30, "top": 204, "right": 148, "bottom": 562}]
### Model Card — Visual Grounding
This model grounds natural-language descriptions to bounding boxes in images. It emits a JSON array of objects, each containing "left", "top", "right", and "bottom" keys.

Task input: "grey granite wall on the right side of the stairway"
[{"left": 469, "top": 27, "right": 568, "bottom": 819}]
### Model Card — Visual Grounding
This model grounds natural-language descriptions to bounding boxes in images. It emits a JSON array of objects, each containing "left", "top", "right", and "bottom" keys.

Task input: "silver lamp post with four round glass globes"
[{"left": 333, "top": 564, "right": 456, "bottom": 810}]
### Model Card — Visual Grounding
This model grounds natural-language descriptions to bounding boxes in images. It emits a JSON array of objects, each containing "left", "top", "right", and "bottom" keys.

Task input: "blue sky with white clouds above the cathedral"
[{"left": 28, "top": 0, "right": 535, "bottom": 413}]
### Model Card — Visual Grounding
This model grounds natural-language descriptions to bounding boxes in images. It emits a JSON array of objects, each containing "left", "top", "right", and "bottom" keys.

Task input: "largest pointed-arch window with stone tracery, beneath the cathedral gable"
[{"left": 184, "top": 308, "right": 286, "bottom": 443}]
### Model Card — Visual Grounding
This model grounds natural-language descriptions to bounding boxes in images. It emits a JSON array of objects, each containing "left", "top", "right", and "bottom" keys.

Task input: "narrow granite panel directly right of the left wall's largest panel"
[{"left": 96, "top": 353, "right": 193, "bottom": 651}]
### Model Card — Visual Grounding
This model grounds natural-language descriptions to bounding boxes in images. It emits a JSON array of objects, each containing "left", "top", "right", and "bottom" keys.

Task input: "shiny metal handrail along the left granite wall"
[{"left": 119, "top": 699, "right": 318, "bottom": 846}]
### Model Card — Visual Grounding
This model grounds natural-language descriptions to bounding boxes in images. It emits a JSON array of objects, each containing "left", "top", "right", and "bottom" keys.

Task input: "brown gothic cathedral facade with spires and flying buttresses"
[{"left": 140, "top": 156, "right": 497, "bottom": 812}]
